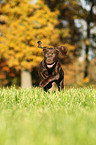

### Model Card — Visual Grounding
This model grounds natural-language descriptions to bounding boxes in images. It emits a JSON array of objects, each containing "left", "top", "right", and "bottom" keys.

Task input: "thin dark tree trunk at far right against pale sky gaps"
[{"left": 81, "top": 0, "right": 96, "bottom": 78}]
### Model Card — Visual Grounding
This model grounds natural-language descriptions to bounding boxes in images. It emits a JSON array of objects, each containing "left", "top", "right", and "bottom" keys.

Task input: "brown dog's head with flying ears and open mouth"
[{"left": 37, "top": 41, "right": 67, "bottom": 68}]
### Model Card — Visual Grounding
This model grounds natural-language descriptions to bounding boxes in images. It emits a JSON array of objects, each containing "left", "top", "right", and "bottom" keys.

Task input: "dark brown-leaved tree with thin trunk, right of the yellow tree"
[{"left": 44, "top": 0, "right": 96, "bottom": 79}]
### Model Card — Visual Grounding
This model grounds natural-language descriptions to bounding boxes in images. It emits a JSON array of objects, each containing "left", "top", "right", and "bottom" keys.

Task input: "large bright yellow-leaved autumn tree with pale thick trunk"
[{"left": 0, "top": 0, "right": 64, "bottom": 87}]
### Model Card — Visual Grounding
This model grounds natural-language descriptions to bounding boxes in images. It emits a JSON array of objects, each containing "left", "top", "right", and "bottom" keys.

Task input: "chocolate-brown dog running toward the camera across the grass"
[{"left": 37, "top": 41, "right": 67, "bottom": 92}]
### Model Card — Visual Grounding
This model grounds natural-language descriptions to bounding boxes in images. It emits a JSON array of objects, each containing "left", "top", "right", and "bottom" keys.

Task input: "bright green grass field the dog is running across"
[{"left": 0, "top": 87, "right": 96, "bottom": 145}]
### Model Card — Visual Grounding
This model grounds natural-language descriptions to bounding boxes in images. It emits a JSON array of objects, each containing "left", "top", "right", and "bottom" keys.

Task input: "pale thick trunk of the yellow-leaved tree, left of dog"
[{"left": 21, "top": 70, "right": 32, "bottom": 88}]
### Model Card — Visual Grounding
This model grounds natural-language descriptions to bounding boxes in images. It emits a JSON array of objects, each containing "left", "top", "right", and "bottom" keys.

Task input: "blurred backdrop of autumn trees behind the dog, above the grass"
[{"left": 0, "top": 0, "right": 96, "bottom": 87}]
